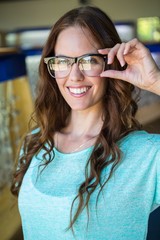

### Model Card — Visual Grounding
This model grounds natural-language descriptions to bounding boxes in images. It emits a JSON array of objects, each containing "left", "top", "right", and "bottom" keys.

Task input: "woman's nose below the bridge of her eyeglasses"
[{"left": 69, "top": 63, "right": 84, "bottom": 82}]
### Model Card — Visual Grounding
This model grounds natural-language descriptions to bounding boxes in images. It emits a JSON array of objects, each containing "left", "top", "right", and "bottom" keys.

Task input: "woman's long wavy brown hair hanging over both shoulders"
[{"left": 11, "top": 6, "right": 139, "bottom": 229}]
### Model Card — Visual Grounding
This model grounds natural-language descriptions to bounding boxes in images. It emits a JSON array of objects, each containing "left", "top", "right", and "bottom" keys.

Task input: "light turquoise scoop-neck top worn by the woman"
[{"left": 19, "top": 131, "right": 160, "bottom": 240}]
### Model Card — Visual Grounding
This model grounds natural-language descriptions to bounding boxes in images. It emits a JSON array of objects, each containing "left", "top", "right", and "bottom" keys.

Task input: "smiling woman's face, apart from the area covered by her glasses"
[{"left": 55, "top": 26, "right": 106, "bottom": 111}]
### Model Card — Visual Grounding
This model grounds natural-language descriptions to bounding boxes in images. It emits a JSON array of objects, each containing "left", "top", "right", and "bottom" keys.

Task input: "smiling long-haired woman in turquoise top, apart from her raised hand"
[{"left": 12, "top": 7, "right": 160, "bottom": 240}]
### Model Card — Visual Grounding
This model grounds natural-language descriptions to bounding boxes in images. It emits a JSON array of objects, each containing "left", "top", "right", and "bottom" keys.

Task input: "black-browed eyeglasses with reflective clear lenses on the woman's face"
[{"left": 44, "top": 54, "right": 107, "bottom": 78}]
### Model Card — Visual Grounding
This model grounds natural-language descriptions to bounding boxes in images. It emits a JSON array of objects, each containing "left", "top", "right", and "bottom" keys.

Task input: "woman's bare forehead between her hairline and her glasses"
[{"left": 55, "top": 26, "right": 100, "bottom": 57}]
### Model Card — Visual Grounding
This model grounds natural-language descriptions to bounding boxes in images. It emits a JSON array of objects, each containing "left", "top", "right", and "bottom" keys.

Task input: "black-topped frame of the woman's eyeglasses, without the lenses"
[{"left": 44, "top": 53, "right": 108, "bottom": 78}]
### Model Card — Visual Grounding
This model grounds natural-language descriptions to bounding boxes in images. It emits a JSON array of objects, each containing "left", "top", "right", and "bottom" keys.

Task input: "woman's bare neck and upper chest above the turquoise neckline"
[{"left": 55, "top": 108, "right": 103, "bottom": 153}]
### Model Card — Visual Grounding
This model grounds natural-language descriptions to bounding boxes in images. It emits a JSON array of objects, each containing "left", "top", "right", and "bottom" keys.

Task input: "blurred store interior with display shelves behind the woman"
[{"left": 0, "top": 0, "right": 160, "bottom": 240}]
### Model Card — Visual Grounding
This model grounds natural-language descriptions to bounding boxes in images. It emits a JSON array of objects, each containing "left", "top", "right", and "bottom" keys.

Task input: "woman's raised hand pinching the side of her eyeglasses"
[{"left": 99, "top": 39, "right": 160, "bottom": 95}]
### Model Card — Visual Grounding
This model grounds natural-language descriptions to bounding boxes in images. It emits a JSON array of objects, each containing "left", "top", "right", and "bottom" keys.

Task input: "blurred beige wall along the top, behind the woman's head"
[{"left": 0, "top": 0, "right": 160, "bottom": 30}]
